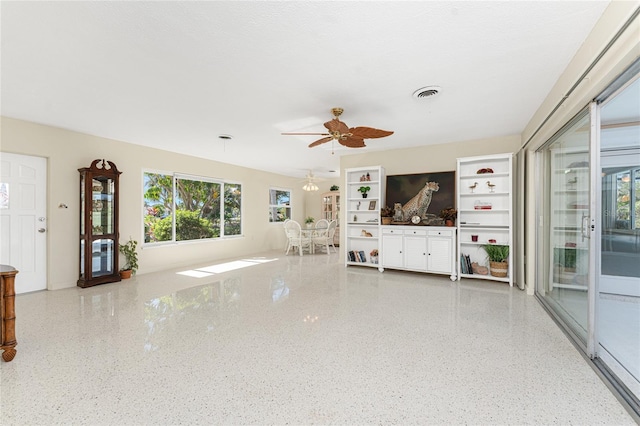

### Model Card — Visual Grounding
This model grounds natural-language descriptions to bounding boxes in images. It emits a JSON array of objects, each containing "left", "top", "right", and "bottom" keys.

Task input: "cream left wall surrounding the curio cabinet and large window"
[{"left": 0, "top": 117, "right": 304, "bottom": 290}]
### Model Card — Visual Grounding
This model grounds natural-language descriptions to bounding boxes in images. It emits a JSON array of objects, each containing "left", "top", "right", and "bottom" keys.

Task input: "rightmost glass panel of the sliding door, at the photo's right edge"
[{"left": 596, "top": 77, "right": 640, "bottom": 398}]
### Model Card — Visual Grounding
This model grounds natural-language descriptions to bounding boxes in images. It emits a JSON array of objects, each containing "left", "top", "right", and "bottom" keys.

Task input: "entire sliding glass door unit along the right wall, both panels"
[{"left": 536, "top": 65, "right": 640, "bottom": 404}]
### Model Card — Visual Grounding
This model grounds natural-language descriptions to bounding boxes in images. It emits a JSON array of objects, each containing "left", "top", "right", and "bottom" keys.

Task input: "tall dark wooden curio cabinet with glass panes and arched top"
[{"left": 78, "top": 159, "right": 121, "bottom": 288}]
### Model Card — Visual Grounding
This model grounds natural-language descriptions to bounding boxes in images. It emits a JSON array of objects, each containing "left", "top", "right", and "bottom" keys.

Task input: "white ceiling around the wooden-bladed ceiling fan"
[{"left": 0, "top": 1, "right": 608, "bottom": 177}]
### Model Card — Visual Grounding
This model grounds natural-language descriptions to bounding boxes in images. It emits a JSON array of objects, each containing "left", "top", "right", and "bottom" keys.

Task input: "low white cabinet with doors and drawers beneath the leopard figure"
[{"left": 380, "top": 225, "right": 456, "bottom": 281}]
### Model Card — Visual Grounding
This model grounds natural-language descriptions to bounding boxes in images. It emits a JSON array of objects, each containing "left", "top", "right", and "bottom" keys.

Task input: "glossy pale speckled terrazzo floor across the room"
[{"left": 0, "top": 252, "right": 634, "bottom": 425}]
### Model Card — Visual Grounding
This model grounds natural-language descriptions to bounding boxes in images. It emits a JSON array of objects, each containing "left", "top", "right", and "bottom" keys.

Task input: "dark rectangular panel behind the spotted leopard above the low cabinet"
[{"left": 385, "top": 171, "right": 456, "bottom": 216}]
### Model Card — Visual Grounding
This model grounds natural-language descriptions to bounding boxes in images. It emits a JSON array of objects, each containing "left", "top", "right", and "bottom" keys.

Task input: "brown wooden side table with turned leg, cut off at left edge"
[{"left": 0, "top": 265, "right": 18, "bottom": 362}]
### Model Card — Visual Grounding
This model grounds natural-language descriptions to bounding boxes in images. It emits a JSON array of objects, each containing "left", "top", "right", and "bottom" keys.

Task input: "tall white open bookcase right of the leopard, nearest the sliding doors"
[{"left": 457, "top": 153, "right": 514, "bottom": 286}]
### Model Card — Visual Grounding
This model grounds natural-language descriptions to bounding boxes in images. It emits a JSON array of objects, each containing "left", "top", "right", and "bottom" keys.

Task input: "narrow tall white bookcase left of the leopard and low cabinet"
[{"left": 342, "top": 166, "right": 386, "bottom": 268}]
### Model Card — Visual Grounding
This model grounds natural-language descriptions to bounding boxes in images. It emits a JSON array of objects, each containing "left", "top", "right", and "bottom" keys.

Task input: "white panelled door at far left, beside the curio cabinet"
[{"left": 0, "top": 152, "right": 47, "bottom": 293}]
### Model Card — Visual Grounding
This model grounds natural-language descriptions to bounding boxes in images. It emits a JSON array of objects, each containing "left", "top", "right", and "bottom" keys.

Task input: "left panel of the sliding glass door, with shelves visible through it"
[{"left": 538, "top": 110, "right": 591, "bottom": 348}]
